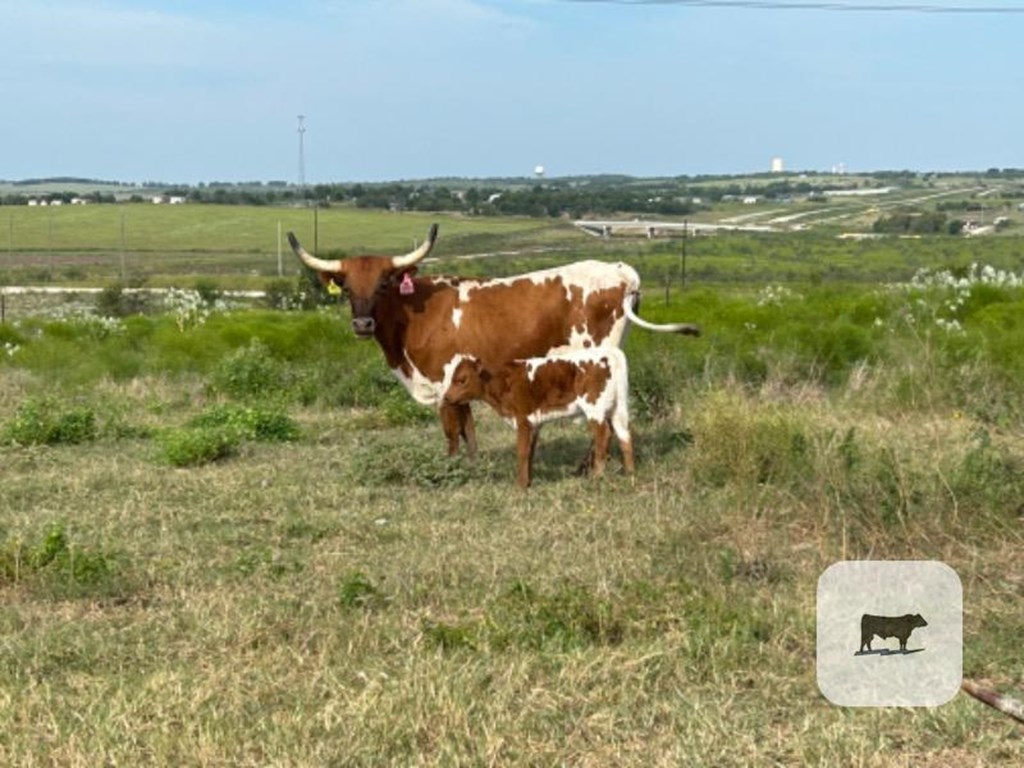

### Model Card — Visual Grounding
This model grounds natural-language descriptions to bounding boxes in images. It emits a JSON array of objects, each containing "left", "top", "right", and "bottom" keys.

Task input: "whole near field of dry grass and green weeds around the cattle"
[{"left": 0, "top": 208, "right": 1024, "bottom": 766}]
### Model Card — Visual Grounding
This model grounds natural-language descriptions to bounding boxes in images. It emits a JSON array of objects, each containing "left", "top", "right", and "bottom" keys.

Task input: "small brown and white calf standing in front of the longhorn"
[{"left": 443, "top": 347, "right": 634, "bottom": 487}]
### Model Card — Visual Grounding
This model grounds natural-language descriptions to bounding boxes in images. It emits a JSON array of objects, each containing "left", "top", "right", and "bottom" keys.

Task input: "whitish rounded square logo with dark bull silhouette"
[{"left": 817, "top": 560, "right": 964, "bottom": 707}]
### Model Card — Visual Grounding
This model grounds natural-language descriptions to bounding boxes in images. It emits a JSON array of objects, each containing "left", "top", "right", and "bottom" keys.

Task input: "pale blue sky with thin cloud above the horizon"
[{"left": 0, "top": 0, "right": 1024, "bottom": 184}]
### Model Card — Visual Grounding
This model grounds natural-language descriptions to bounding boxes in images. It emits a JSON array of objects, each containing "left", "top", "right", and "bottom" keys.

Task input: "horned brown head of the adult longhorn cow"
[{"left": 288, "top": 224, "right": 437, "bottom": 339}]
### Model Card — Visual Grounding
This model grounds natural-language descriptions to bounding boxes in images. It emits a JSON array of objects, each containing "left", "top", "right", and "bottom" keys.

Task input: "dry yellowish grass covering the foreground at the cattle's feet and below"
[{"left": 0, "top": 372, "right": 1024, "bottom": 766}]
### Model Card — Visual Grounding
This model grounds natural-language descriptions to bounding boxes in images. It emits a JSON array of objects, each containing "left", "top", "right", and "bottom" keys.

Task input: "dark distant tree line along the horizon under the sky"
[{"left": 8, "top": 168, "right": 1024, "bottom": 222}]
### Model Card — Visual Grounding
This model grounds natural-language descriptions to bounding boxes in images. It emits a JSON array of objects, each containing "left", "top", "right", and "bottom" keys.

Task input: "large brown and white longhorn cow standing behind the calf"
[{"left": 288, "top": 224, "right": 700, "bottom": 456}]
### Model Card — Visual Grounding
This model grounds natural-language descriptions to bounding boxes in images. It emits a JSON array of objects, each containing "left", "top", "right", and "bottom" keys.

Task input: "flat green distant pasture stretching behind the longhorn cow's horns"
[{"left": 0, "top": 203, "right": 1024, "bottom": 292}]
